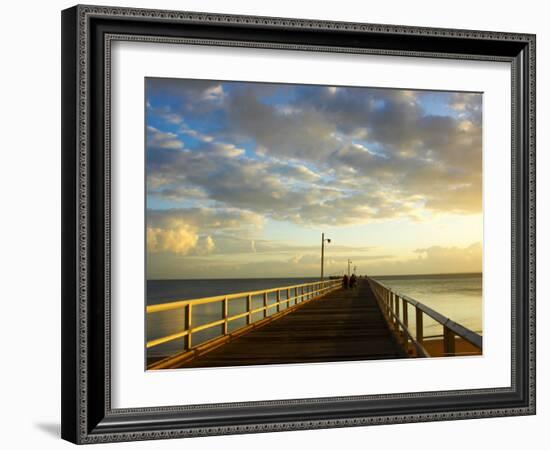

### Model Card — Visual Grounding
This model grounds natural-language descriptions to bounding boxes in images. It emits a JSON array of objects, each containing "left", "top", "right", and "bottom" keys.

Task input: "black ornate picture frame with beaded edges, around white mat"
[{"left": 62, "top": 6, "right": 535, "bottom": 443}]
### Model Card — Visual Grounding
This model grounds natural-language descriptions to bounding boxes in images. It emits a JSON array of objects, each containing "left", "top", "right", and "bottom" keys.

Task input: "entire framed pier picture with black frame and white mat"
[{"left": 62, "top": 6, "right": 535, "bottom": 444}]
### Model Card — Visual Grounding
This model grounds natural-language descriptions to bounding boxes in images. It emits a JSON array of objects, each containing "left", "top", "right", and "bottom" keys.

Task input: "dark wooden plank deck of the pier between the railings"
[{"left": 174, "top": 280, "right": 407, "bottom": 368}]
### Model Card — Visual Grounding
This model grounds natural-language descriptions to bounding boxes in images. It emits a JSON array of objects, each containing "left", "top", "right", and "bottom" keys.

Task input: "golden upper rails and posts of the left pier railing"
[{"left": 146, "top": 279, "right": 342, "bottom": 352}]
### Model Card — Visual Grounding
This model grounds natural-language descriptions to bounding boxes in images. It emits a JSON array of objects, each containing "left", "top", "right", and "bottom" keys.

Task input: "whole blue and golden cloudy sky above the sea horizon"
[{"left": 146, "top": 78, "right": 482, "bottom": 279}]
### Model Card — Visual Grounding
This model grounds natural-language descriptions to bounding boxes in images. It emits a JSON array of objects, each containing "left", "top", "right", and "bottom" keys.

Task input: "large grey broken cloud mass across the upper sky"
[{"left": 148, "top": 80, "right": 481, "bottom": 225}]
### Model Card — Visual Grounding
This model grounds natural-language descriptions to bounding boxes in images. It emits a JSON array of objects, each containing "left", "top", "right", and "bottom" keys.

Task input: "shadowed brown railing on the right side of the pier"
[{"left": 368, "top": 277, "right": 483, "bottom": 357}]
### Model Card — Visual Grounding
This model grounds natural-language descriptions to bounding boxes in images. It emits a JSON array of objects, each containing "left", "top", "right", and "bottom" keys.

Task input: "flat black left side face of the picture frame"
[{"left": 61, "top": 7, "right": 78, "bottom": 442}]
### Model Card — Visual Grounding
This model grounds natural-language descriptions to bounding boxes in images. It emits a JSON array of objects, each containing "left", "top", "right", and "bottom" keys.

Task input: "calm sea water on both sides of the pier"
[{"left": 147, "top": 274, "right": 482, "bottom": 358}]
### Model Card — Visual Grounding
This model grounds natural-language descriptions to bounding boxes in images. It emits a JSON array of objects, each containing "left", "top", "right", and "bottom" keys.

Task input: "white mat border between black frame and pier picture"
[{"left": 111, "top": 42, "right": 511, "bottom": 408}]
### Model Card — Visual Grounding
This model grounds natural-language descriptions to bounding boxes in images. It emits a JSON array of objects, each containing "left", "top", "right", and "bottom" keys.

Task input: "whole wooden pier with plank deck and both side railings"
[{"left": 147, "top": 278, "right": 481, "bottom": 370}]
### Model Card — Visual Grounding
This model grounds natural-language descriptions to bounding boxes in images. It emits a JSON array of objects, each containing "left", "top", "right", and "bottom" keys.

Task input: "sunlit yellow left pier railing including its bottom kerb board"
[{"left": 146, "top": 278, "right": 342, "bottom": 369}]
